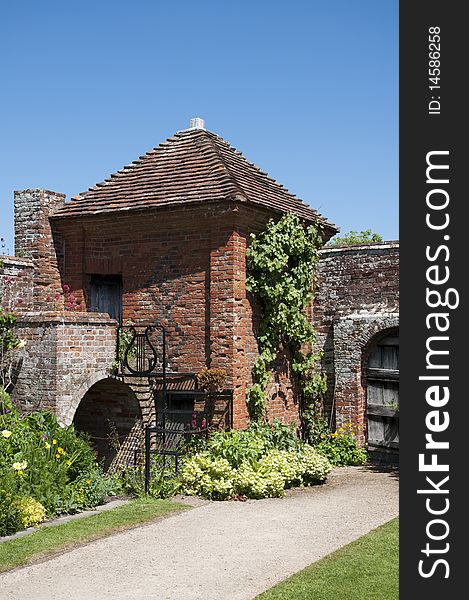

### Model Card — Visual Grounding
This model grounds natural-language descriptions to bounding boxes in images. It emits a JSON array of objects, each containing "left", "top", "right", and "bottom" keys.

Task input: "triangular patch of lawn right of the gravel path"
[{"left": 257, "top": 519, "right": 399, "bottom": 600}]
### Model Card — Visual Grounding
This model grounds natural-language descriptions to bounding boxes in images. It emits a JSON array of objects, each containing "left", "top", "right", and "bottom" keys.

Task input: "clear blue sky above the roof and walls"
[{"left": 0, "top": 0, "right": 398, "bottom": 253}]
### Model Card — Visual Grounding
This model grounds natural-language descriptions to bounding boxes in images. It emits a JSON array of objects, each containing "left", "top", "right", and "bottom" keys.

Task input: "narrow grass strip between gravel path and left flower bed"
[{"left": 0, "top": 498, "right": 187, "bottom": 573}]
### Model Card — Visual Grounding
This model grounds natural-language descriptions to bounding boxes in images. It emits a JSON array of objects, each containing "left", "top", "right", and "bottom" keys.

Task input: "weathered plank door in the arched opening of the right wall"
[{"left": 365, "top": 330, "right": 399, "bottom": 460}]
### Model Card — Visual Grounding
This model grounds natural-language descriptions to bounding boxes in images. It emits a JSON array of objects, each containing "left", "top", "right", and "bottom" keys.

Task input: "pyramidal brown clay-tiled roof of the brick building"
[{"left": 54, "top": 128, "right": 337, "bottom": 235}]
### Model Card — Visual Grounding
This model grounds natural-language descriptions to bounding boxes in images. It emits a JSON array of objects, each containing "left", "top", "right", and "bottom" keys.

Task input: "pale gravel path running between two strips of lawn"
[{"left": 0, "top": 467, "right": 399, "bottom": 600}]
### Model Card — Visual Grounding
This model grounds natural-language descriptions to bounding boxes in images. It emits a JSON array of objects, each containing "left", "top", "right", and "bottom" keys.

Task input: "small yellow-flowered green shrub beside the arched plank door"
[{"left": 315, "top": 423, "right": 368, "bottom": 466}]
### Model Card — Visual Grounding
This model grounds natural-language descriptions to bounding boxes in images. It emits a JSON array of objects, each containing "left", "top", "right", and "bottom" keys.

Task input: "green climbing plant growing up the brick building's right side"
[{"left": 246, "top": 213, "right": 326, "bottom": 421}]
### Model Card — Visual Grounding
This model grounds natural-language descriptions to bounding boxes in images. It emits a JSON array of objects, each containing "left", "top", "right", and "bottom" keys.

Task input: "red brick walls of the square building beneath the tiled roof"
[{"left": 53, "top": 203, "right": 298, "bottom": 427}]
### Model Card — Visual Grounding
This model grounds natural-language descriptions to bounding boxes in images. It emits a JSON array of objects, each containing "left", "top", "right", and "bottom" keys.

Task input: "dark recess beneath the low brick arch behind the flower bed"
[{"left": 73, "top": 377, "right": 142, "bottom": 468}]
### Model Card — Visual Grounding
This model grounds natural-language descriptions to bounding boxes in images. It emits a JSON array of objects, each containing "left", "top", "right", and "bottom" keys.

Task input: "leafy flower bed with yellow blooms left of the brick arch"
[{"left": 0, "top": 392, "right": 118, "bottom": 529}]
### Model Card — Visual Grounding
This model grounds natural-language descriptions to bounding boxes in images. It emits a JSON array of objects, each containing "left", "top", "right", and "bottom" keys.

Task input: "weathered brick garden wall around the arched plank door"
[{"left": 313, "top": 242, "right": 399, "bottom": 439}]
